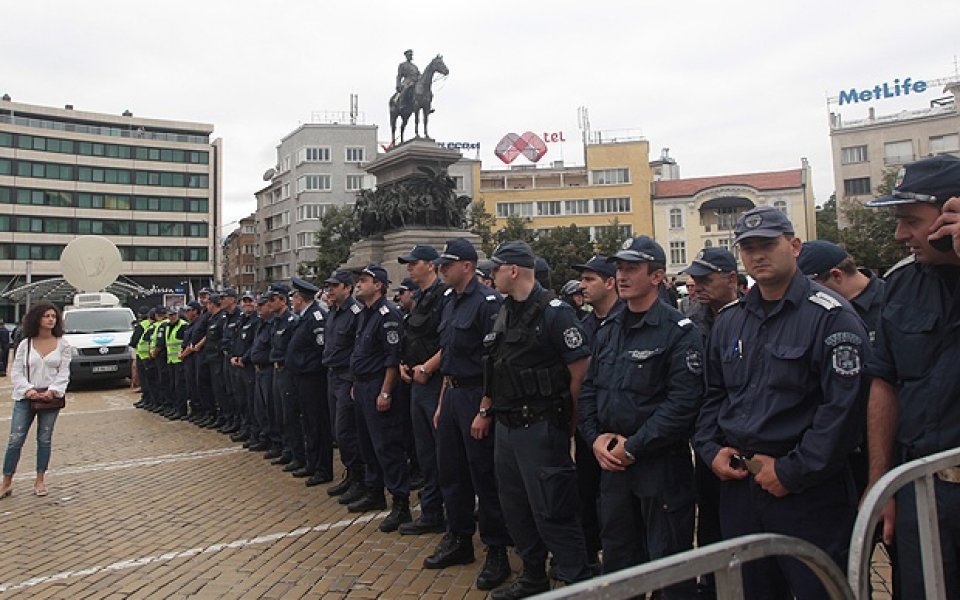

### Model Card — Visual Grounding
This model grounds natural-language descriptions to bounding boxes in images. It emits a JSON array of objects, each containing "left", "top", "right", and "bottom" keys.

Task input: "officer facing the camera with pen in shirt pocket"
[{"left": 695, "top": 206, "right": 870, "bottom": 599}]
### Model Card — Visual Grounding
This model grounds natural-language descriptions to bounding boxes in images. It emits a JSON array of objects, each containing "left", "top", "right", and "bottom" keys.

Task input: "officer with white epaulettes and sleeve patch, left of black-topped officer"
[{"left": 348, "top": 264, "right": 413, "bottom": 532}]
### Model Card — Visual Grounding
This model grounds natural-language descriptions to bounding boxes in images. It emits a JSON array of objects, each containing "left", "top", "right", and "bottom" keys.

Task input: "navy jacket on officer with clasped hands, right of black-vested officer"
[{"left": 578, "top": 300, "right": 703, "bottom": 457}]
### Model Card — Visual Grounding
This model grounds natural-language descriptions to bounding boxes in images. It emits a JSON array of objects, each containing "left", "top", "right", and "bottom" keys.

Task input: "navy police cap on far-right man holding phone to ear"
[{"left": 866, "top": 154, "right": 960, "bottom": 208}]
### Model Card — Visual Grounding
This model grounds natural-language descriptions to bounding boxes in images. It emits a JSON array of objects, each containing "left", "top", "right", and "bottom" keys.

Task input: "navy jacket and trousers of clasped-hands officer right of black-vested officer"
[{"left": 578, "top": 301, "right": 703, "bottom": 598}]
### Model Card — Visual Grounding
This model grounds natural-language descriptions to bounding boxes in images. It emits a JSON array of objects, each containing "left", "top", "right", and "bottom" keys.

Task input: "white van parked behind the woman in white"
[{"left": 63, "top": 292, "right": 135, "bottom": 381}]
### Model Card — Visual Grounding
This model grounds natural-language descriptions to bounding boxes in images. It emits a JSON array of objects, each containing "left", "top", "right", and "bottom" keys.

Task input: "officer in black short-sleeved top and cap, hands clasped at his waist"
[{"left": 397, "top": 244, "right": 446, "bottom": 535}]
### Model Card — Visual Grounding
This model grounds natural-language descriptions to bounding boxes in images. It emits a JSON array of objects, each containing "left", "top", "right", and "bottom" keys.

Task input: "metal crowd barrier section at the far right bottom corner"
[{"left": 847, "top": 448, "right": 960, "bottom": 600}]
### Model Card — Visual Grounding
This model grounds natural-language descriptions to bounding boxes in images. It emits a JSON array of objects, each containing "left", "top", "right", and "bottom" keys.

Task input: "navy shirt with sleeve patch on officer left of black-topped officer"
[{"left": 350, "top": 296, "right": 403, "bottom": 376}]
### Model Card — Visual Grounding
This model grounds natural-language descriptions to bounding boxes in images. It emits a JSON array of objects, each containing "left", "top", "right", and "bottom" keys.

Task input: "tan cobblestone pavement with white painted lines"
[{"left": 0, "top": 379, "right": 519, "bottom": 599}]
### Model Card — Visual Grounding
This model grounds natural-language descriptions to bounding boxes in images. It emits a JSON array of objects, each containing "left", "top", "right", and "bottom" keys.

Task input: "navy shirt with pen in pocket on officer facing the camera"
[{"left": 694, "top": 270, "right": 870, "bottom": 492}]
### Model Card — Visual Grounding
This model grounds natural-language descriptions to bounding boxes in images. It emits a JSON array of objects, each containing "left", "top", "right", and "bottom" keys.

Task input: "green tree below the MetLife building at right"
[{"left": 839, "top": 167, "right": 907, "bottom": 273}]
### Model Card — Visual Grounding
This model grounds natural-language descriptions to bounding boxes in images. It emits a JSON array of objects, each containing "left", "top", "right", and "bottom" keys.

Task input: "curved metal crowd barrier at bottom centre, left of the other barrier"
[{"left": 536, "top": 533, "right": 855, "bottom": 600}]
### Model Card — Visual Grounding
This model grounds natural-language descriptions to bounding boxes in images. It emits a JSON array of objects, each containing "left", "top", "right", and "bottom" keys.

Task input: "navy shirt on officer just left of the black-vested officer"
[{"left": 440, "top": 278, "right": 501, "bottom": 379}]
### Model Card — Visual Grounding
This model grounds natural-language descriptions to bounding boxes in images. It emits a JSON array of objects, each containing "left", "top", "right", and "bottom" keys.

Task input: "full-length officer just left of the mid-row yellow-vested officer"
[{"left": 287, "top": 277, "right": 333, "bottom": 486}]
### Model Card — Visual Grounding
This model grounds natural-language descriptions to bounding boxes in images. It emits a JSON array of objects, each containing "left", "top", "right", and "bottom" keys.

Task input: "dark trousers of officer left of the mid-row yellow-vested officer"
[{"left": 293, "top": 369, "right": 333, "bottom": 477}]
